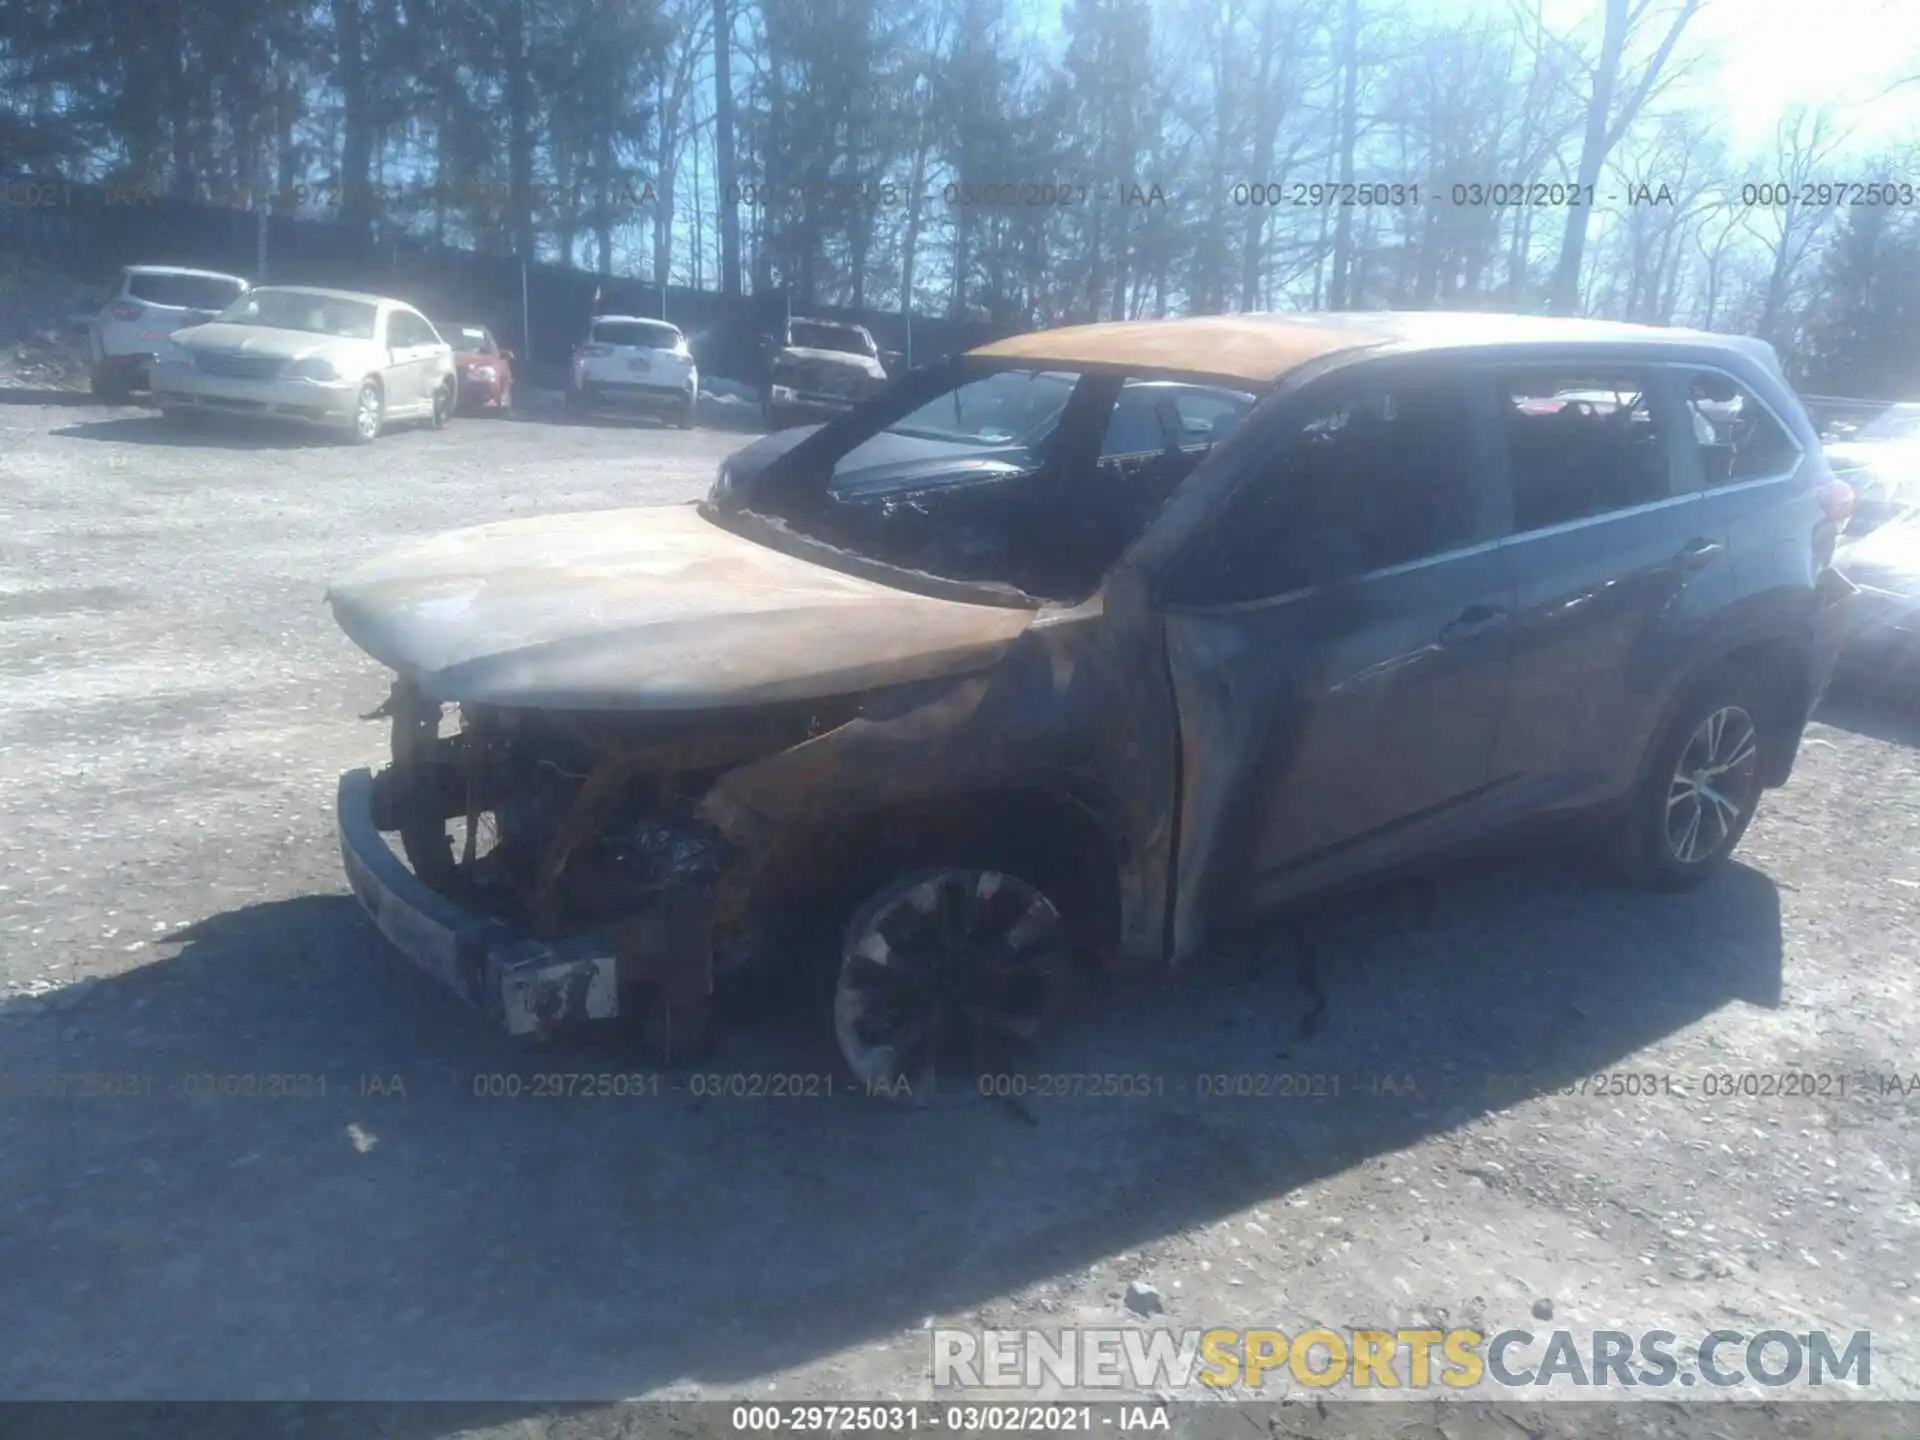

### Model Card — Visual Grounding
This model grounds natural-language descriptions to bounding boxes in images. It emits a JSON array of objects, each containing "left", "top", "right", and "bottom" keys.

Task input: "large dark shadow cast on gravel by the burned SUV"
[{"left": 0, "top": 852, "right": 1782, "bottom": 1413}]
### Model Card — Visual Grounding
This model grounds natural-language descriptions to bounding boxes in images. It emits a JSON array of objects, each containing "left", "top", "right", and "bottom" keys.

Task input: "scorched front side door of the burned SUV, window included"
[{"left": 1164, "top": 363, "right": 1515, "bottom": 954}]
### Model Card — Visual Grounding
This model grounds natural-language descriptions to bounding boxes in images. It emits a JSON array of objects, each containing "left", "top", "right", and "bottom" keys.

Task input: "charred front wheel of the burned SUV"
[{"left": 833, "top": 870, "right": 1071, "bottom": 1098}]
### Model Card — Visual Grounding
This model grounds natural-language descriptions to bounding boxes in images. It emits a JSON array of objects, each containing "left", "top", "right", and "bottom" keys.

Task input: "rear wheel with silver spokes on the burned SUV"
[{"left": 1613, "top": 672, "right": 1772, "bottom": 891}]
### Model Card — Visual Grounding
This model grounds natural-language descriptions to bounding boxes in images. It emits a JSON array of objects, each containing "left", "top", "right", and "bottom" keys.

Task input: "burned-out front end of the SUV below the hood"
[{"left": 340, "top": 680, "right": 845, "bottom": 1054}]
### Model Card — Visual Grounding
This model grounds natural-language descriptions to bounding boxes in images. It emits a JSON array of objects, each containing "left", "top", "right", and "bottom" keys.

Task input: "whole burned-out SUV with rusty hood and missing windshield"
[{"left": 330, "top": 313, "right": 1851, "bottom": 1087}]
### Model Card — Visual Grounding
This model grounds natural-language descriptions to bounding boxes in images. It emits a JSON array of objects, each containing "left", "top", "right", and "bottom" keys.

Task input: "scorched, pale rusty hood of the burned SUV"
[{"left": 326, "top": 505, "right": 1033, "bottom": 710}]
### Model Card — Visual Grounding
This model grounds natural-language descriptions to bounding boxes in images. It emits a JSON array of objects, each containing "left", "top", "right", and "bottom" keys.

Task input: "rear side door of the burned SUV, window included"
[{"left": 1486, "top": 361, "right": 1730, "bottom": 810}]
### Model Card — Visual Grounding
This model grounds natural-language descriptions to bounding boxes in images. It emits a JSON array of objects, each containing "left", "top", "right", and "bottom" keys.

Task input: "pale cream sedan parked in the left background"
[{"left": 154, "top": 286, "right": 457, "bottom": 444}]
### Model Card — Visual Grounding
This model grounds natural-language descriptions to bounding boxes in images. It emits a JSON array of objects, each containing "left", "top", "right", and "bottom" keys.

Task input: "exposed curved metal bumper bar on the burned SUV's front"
[{"left": 338, "top": 770, "right": 620, "bottom": 1035}]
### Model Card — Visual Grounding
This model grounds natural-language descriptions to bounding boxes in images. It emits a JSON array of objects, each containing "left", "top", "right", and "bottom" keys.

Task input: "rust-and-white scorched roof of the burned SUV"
[{"left": 970, "top": 311, "right": 1753, "bottom": 384}]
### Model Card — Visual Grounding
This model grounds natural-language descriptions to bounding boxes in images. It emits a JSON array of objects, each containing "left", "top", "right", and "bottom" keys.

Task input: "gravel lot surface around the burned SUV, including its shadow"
[{"left": 0, "top": 388, "right": 1920, "bottom": 1436}]
